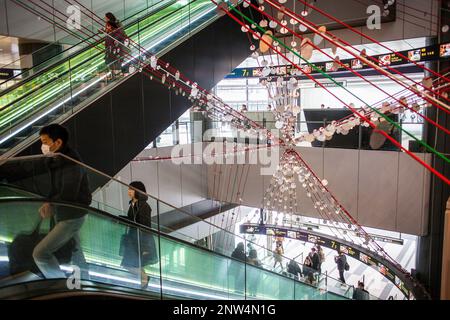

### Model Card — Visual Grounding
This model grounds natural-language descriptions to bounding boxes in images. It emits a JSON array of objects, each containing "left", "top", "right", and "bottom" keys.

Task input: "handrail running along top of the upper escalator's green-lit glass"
[{"left": 0, "top": 0, "right": 178, "bottom": 91}]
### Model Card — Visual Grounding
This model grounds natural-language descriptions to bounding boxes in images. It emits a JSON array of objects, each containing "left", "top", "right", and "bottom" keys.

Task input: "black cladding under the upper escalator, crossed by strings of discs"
[{"left": 23, "top": 17, "right": 250, "bottom": 189}]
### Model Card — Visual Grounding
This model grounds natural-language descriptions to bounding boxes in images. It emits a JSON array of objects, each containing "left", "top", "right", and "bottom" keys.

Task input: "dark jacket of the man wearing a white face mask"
[{"left": 46, "top": 146, "right": 92, "bottom": 221}]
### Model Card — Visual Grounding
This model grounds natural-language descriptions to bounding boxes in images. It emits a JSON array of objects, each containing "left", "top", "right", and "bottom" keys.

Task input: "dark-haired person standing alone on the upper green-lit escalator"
[{"left": 103, "top": 12, "right": 129, "bottom": 79}]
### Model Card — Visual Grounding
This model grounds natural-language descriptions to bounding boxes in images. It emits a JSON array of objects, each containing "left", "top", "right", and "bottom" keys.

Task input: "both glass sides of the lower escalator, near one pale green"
[{"left": 0, "top": 155, "right": 353, "bottom": 299}]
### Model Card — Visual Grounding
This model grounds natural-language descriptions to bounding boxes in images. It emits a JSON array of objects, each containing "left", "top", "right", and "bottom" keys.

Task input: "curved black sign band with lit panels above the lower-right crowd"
[{"left": 240, "top": 223, "right": 410, "bottom": 298}]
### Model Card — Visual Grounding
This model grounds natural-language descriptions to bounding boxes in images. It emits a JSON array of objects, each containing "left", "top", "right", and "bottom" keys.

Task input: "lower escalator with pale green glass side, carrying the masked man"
[{"left": 0, "top": 156, "right": 353, "bottom": 300}]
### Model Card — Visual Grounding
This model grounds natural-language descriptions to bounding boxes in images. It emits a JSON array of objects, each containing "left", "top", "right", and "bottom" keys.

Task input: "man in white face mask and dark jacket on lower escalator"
[{"left": 33, "top": 124, "right": 92, "bottom": 278}]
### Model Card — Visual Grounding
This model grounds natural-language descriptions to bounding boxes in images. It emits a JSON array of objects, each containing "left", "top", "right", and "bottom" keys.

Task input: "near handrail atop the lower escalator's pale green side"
[{"left": 0, "top": 198, "right": 346, "bottom": 297}]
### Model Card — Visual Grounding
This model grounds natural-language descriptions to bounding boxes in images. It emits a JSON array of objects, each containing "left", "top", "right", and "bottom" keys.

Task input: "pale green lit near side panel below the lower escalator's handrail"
[{"left": 0, "top": 198, "right": 346, "bottom": 300}]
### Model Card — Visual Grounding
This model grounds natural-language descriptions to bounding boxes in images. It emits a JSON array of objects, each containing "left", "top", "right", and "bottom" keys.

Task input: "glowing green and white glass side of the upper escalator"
[{"left": 0, "top": 0, "right": 223, "bottom": 152}]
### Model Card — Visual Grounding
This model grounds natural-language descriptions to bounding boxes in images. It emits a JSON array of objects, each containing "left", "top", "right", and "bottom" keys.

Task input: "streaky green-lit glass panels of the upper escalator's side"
[{"left": 0, "top": 0, "right": 213, "bottom": 141}]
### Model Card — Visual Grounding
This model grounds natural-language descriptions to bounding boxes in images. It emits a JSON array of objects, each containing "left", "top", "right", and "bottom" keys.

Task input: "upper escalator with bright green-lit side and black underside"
[{"left": 0, "top": 0, "right": 250, "bottom": 185}]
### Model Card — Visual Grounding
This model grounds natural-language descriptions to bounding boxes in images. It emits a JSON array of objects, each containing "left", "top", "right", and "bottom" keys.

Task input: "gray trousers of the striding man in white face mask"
[{"left": 33, "top": 217, "right": 87, "bottom": 279}]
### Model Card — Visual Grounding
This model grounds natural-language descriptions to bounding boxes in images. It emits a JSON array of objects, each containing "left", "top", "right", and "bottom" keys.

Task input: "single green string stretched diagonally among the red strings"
[{"left": 231, "top": 3, "right": 450, "bottom": 163}]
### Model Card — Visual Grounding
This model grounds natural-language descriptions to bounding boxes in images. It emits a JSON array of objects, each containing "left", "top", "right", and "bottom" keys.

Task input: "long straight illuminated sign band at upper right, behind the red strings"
[{"left": 225, "top": 43, "right": 450, "bottom": 79}]
